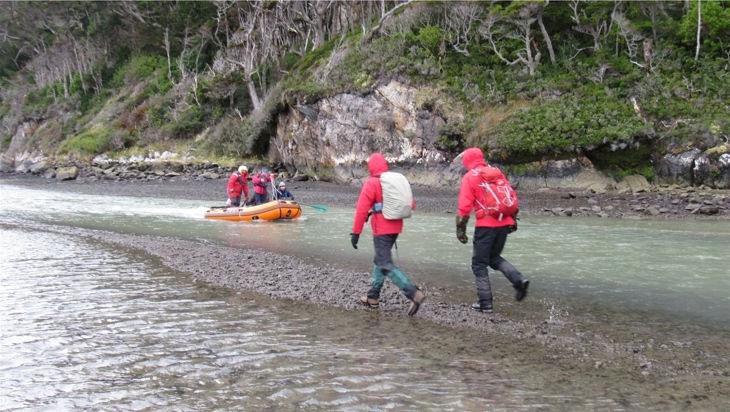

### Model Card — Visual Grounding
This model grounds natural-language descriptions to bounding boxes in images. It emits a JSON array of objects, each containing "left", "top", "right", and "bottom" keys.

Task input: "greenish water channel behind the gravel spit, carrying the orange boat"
[{"left": 0, "top": 185, "right": 730, "bottom": 325}]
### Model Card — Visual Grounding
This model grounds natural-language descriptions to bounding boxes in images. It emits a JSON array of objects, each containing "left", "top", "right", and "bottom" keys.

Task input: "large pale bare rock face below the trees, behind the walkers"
[{"left": 269, "top": 81, "right": 447, "bottom": 181}]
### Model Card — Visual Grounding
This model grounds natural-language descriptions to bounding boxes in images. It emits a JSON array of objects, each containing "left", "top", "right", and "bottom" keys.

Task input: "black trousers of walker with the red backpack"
[{"left": 471, "top": 227, "right": 523, "bottom": 306}]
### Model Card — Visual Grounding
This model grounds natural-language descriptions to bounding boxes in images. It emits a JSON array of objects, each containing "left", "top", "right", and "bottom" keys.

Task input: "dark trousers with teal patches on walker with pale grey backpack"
[{"left": 368, "top": 234, "right": 416, "bottom": 299}]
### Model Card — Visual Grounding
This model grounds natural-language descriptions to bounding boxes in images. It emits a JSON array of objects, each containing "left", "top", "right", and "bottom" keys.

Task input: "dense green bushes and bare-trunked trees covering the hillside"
[{"left": 0, "top": 0, "right": 730, "bottom": 175}]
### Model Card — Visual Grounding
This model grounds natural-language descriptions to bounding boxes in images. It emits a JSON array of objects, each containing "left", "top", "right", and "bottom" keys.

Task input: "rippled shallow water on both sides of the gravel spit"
[{"left": 0, "top": 184, "right": 730, "bottom": 410}]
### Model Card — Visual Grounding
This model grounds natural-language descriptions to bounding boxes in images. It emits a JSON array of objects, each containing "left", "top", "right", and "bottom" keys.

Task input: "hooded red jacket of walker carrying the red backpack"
[{"left": 456, "top": 147, "right": 515, "bottom": 227}]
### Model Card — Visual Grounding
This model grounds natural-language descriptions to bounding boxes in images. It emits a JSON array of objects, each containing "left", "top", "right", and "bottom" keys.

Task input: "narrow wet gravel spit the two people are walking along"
[{"left": 0, "top": 222, "right": 730, "bottom": 408}]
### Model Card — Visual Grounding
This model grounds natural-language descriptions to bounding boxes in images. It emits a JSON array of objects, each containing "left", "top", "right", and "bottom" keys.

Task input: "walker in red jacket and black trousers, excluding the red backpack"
[{"left": 456, "top": 147, "right": 530, "bottom": 313}]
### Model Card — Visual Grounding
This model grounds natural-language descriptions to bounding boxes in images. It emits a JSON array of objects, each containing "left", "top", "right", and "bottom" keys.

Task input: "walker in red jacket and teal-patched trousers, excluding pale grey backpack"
[{"left": 350, "top": 153, "right": 426, "bottom": 316}]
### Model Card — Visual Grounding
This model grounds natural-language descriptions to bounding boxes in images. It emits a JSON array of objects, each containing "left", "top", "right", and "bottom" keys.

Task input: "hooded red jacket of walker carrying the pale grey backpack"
[{"left": 352, "top": 153, "right": 416, "bottom": 236}]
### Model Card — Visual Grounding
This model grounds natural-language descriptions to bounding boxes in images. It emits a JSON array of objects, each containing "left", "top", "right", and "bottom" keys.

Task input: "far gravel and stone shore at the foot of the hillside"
[{"left": 0, "top": 173, "right": 730, "bottom": 220}]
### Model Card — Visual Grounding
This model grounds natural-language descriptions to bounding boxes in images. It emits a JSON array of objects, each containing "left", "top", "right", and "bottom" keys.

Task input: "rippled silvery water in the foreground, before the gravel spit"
[{"left": 0, "top": 229, "right": 617, "bottom": 410}]
